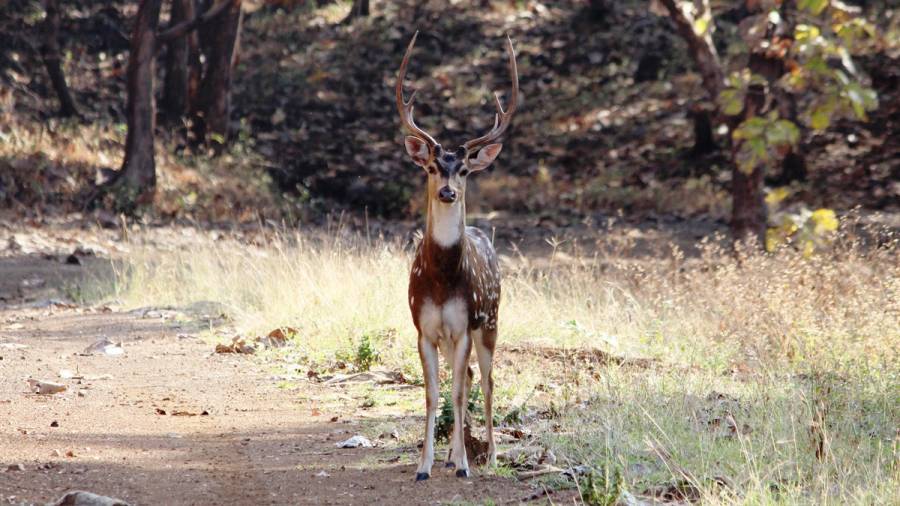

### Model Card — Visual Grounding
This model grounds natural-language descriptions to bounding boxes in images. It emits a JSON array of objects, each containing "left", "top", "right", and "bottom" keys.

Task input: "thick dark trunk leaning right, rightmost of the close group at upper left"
[{"left": 194, "top": 0, "right": 242, "bottom": 144}]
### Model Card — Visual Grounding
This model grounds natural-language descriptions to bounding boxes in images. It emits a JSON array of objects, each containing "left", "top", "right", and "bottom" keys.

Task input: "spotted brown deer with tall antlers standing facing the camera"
[{"left": 396, "top": 32, "right": 519, "bottom": 481}]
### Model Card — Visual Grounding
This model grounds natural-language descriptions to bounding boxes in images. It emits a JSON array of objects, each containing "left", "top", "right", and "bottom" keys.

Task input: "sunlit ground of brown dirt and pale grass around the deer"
[{"left": 0, "top": 214, "right": 900, "bottom": 505}]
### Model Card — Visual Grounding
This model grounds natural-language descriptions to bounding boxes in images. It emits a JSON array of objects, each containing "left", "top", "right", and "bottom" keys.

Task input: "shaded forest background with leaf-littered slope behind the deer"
[{"left": 0, "top": 0, "right": 900, "bottom": 245}]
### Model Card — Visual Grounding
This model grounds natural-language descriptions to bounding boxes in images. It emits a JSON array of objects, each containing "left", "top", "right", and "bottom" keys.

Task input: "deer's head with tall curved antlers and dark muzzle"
[{"left": 396, "top": 32, "right": 519, "bottom": 210}]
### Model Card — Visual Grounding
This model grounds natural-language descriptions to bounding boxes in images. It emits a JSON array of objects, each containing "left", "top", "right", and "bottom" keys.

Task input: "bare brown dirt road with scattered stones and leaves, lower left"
[{"left": 0, "top": 257, "right": 534, "bottom": 505}]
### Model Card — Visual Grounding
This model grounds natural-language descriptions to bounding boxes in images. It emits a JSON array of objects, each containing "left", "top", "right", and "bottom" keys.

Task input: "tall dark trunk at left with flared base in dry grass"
[{"left": 107, "top": 0, "right": 162, "bottom": 212}]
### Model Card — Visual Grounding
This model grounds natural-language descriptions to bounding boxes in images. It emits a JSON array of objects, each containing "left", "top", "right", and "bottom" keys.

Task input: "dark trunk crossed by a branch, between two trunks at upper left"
[{"left": 159, "top": 0, "right": 197, "bottom": 123}]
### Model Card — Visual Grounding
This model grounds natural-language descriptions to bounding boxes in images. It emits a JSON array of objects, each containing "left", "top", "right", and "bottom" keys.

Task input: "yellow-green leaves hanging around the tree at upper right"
[{"left": 717, "top": 0, "right": 880, "bottom": 173}]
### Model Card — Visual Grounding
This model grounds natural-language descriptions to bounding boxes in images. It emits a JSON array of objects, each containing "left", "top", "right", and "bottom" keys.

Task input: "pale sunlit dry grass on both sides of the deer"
[{"left": 95, "top": 225, "right": 900, "bottom": 504}]
